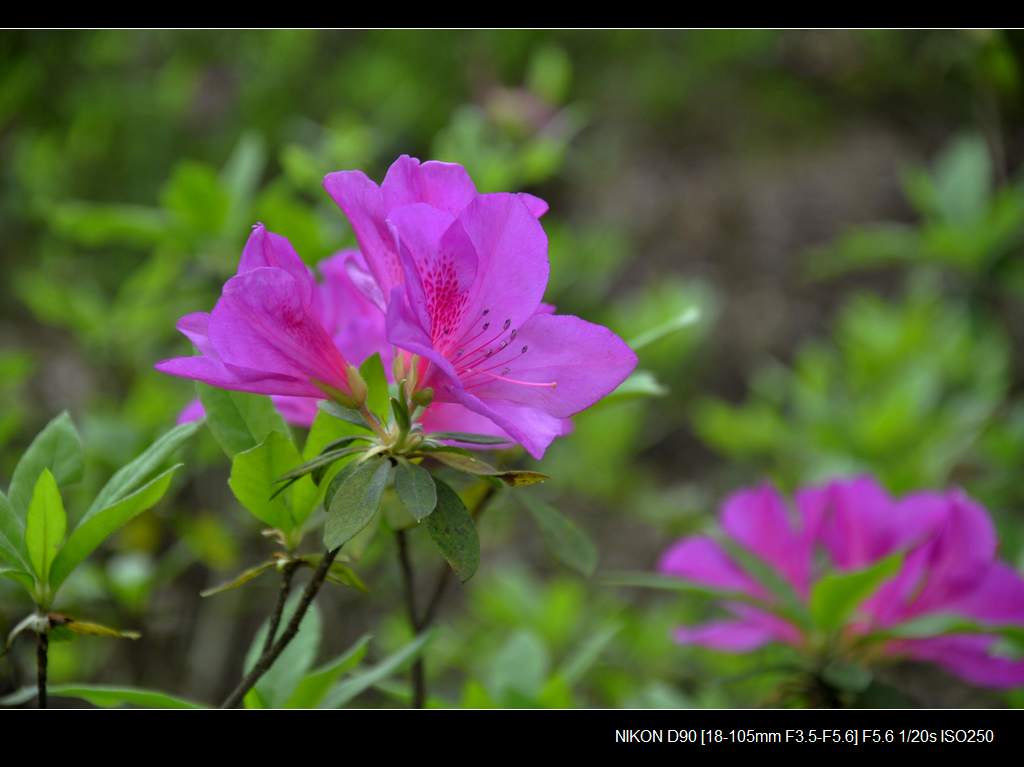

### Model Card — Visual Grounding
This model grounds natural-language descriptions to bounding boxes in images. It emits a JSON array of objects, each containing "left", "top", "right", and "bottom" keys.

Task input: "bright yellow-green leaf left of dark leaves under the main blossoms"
[{"left": 227, "top": 431, "right": 317, "bottom": 534}]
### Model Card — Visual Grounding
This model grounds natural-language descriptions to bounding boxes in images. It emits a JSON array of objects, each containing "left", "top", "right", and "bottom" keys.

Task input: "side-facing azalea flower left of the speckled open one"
[{"left": 156, "top": 224, "right": 384, "bottom": 410}]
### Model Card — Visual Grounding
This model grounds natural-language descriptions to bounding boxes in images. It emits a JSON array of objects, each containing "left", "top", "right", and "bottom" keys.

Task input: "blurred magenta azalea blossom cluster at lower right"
[{"left": 659, "top": 477, "right": 1024, "bottom": 687}]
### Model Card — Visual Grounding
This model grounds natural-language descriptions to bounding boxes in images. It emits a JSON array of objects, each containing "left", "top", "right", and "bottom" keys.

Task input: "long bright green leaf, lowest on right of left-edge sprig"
[{"left": 50, "top": 464, "right": 183, "bottom": 592}]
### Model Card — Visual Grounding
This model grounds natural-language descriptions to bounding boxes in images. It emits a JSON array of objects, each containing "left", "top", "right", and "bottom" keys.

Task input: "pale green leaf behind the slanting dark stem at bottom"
[{"left": 245, "top": 592, "right": 322, "bottom": 709}]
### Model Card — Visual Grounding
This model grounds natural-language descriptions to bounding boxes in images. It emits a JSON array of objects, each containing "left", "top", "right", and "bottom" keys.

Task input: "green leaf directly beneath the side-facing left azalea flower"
[{"left": 196, "top": 384, "right": 291, "bottom": 458}]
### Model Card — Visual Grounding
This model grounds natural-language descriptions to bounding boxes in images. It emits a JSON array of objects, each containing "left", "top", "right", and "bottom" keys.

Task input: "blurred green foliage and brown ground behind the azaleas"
[{"left": 0, "top": 31, "right": 1024, "bottom": 707}]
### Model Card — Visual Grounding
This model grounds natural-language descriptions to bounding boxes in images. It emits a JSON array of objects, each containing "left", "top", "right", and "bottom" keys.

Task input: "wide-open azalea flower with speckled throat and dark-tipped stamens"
[{"left": 325, "top": 157, "right": 637, "bottom": 458}]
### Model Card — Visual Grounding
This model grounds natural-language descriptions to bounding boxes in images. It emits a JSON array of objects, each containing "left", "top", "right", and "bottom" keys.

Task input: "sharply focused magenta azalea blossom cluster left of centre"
[{"left": 157, "top": 156, "right": 637, "bottom": 458}]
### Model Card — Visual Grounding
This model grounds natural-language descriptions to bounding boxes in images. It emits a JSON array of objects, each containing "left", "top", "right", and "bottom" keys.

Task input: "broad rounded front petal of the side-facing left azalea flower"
[{"left": 210, "top": 267, "right": 348, "bottom": 396}]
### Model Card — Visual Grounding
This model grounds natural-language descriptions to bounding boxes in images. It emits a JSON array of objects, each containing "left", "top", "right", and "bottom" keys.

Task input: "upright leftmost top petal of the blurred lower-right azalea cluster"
[{"left": 722, "top": 484, "right": 813, "bottom": 595}]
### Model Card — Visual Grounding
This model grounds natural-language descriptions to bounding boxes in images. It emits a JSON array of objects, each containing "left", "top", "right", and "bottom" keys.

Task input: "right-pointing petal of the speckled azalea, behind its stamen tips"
[{"left": 456, "top": 314, "right": 637, "bottom": 418}]
